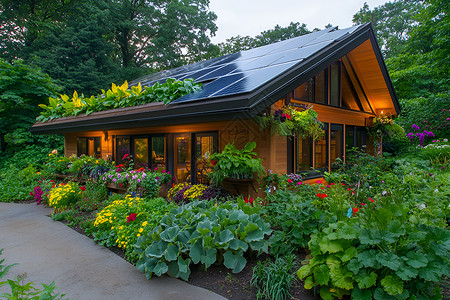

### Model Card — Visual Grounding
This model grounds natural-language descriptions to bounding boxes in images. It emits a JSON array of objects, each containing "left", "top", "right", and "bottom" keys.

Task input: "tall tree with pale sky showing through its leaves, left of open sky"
[{"left": 98, "top": 0, "right": 217, "bottom": 69}]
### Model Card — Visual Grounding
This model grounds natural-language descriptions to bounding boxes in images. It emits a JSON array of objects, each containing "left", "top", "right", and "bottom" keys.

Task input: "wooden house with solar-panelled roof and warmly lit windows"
[{"left": 31, "top": 24, "right": 400, "bottom": 188}]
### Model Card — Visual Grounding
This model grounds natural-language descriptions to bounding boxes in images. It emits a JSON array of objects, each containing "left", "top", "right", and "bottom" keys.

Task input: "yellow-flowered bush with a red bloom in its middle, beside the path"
[{"left": 87, "top": 195, "right": 175, "bottom": 260}]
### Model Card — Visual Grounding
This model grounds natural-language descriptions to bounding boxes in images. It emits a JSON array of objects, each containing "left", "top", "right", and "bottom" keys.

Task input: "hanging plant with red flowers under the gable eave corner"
[{"left": 256, "top": 105, "right": 323, "bottom": 140}]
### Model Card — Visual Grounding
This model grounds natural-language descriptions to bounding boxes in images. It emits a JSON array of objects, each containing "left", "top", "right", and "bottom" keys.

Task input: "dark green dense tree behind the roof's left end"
[{"left": 28, "top": 5, "right": 122, "bottom": 95}]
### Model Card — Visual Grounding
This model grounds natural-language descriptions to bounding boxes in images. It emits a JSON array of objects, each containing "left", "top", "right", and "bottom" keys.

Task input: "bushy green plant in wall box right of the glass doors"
[{"left": 211, "top": 142, "right": 265, "bottom": 185}]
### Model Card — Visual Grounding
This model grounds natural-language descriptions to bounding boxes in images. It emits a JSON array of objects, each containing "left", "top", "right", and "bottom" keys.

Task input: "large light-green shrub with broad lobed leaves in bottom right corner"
[{"left": 298, "top": 192, "right": 450, "bottom": 299}]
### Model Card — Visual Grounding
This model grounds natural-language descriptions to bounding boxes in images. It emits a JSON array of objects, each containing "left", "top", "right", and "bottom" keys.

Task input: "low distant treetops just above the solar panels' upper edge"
[{"left": 219, "top": 22, "right": 312, "bottom": 55}]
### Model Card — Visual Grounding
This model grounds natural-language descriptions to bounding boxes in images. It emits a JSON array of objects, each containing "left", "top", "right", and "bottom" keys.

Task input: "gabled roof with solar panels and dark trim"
[{"left": 31, "top": 24, "right": 399, "bottom": 134}]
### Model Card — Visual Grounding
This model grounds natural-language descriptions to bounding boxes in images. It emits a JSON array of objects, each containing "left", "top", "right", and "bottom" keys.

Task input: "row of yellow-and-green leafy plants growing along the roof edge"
[{"left": 37, "top": 78, "right": 201, "bottom": 122}]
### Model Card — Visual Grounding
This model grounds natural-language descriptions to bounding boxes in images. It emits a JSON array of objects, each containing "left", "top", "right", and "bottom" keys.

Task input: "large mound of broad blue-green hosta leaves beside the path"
[{"left": 135, "top": 200, "right": 272, "bottom": 280}]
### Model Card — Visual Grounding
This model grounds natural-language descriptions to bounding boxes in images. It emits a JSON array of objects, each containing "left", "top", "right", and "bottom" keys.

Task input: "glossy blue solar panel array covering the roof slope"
[{"left": 130, "top": 26, "right": 358, "bottom": 103}]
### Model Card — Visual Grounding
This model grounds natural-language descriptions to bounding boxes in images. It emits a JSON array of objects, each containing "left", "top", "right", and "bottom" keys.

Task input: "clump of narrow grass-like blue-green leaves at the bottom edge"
[{"left": 250, "top": 254, "right": 296, "bottom": 300}]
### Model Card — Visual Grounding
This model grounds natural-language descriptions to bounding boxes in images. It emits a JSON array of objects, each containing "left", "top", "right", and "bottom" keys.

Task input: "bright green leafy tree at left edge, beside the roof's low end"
[{"left": 0, "top": 59, "right": 58, "bottom": 152}]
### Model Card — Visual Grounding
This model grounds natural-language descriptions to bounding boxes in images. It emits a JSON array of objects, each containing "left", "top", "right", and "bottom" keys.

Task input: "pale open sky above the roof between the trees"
[{"left": 209, "top": 0, "right": 387, "bottom": 44}]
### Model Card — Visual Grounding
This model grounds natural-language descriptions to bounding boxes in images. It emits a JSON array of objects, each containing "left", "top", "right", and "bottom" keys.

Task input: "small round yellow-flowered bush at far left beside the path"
[{"left": 48, "top": 182, "right": 82, "bottom": 211}]
